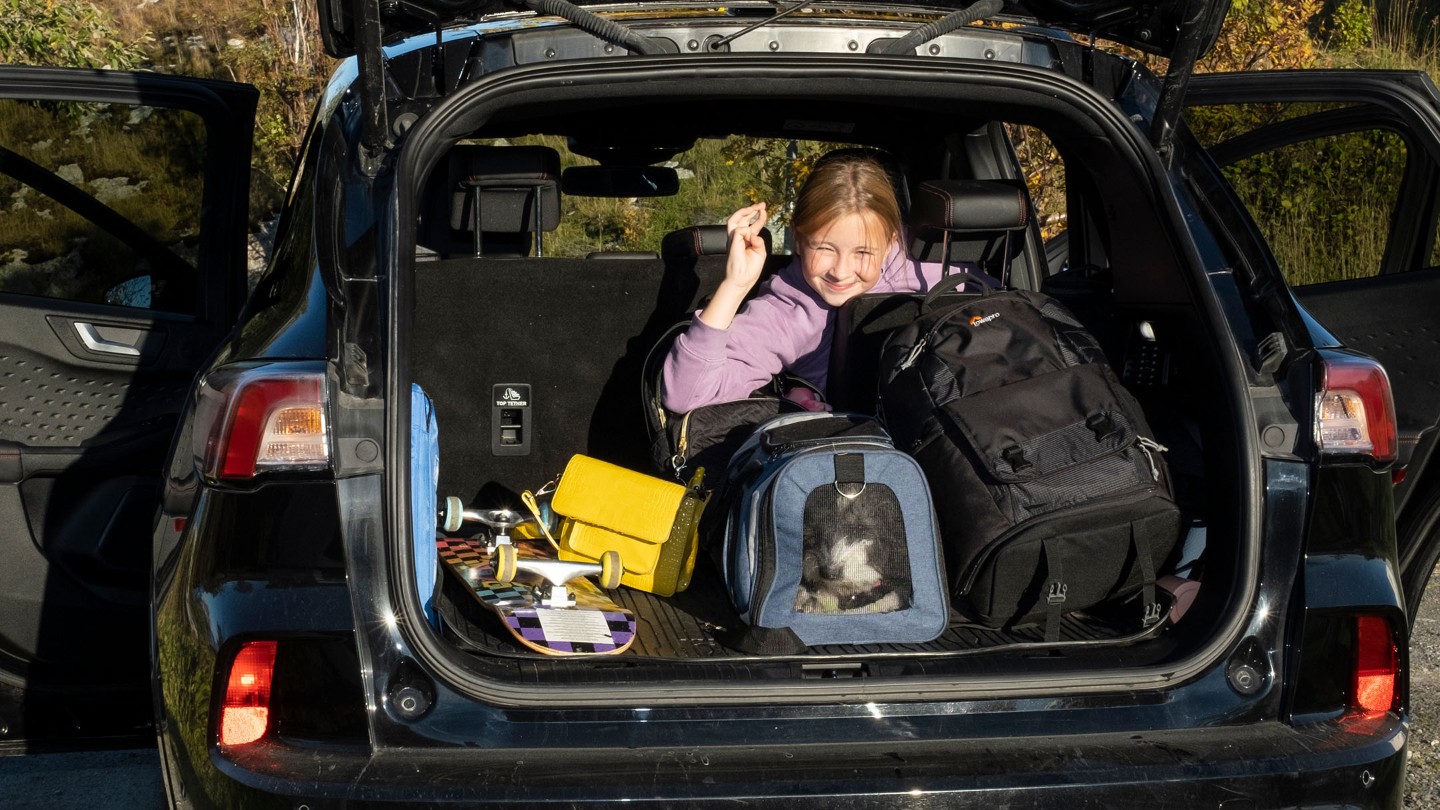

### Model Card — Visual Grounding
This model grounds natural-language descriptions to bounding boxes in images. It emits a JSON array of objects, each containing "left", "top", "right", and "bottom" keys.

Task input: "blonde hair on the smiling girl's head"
[{"left": 791, "top": 156, "right": 901, "bottom": 241}]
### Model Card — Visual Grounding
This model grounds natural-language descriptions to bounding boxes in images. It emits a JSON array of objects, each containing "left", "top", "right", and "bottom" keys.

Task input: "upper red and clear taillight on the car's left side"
[{"left": 194, "top": 363, "right": 330, "bottom": 480}]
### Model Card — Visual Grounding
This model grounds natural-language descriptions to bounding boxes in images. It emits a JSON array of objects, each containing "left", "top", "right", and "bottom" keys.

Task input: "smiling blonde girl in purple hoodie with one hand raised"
[{"left": 662, "top": 154, "right": 940, "bottom": 412}]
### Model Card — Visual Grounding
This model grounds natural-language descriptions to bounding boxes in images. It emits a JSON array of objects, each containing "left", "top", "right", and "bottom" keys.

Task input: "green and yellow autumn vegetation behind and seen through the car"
[{"left": 0, "top": 0, "right": 1440, "bottom": 265}]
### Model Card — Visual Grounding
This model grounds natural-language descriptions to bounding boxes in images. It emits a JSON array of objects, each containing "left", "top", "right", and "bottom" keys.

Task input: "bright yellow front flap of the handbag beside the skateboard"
[{"left": 552, "top": 455, "right": 685, "bottom": 543}]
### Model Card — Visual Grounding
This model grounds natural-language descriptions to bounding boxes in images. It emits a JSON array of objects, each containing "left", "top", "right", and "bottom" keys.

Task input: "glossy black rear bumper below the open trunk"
[{"left": 215, "top": 716, "right": 1407, "bottom": 810}]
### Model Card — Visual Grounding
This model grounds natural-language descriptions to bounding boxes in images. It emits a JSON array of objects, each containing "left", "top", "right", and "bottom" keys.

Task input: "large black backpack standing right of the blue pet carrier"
[{"left": 878, "top": 274, "right": 1179, "bottom": 641}]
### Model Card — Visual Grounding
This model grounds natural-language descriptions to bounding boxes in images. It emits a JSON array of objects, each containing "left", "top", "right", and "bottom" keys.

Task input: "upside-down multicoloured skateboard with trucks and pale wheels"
[{"left": 436, "top": 510, "right": 635, "bottom": 656}]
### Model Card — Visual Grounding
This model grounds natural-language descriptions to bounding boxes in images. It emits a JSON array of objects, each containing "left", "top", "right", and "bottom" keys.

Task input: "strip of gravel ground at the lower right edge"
[{"left": 1404, "top": 568, "right": 1440, "bottom": 810}]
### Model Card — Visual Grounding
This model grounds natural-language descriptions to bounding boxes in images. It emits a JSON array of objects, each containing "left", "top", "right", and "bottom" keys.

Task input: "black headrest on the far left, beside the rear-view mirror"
[{"left": 451, "top": 144, "right": 560, "bottom": 233}]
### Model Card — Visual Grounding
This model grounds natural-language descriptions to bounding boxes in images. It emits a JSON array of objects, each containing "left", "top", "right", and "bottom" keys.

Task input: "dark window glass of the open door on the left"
[{"left": 0, "top": 99, "right": 204, "bottom": 313}]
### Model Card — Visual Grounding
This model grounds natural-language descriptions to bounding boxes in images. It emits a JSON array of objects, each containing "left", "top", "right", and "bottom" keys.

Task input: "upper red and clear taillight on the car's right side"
[{"left": 1315, "top": 352, "right": 1395, "bottom": 464}]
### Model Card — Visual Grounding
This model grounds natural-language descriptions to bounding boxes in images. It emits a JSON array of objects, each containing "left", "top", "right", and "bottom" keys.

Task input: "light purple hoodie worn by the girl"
[{"left": 661, "top": 245, "right": 940, "bottom": 414}]
